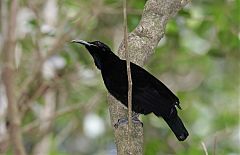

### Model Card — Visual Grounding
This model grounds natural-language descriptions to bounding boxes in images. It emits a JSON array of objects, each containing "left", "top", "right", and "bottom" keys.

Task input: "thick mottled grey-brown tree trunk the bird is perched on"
[{"left": 108, "top": 0, "right": 188, "bottom": 155}]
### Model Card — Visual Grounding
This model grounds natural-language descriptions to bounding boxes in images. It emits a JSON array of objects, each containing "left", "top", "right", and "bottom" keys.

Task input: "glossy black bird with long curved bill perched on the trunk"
[{"left": 72, "top": 40, "right": 188, "bottom": 141}]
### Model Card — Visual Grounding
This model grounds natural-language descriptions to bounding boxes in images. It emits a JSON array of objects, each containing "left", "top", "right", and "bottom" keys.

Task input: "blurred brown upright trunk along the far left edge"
[{"left": 3, "top": 0, "right": 26, "bottom": 155}]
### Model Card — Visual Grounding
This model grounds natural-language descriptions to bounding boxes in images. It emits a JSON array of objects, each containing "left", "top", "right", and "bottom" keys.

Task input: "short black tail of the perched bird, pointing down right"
[{"left": 164, "top": 115, "right": 189, "bottom": 141}]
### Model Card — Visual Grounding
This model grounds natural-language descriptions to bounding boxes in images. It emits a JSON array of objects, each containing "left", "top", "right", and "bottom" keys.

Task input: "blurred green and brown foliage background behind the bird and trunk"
[{"left": 0, "top": 0, "right": 240, "bottom": 155}]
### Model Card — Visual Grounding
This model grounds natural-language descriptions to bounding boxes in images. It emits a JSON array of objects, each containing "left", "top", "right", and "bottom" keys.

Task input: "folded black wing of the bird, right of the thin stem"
[{"left": 131, "top": 64, "right": 179, "bottom": 115}]
